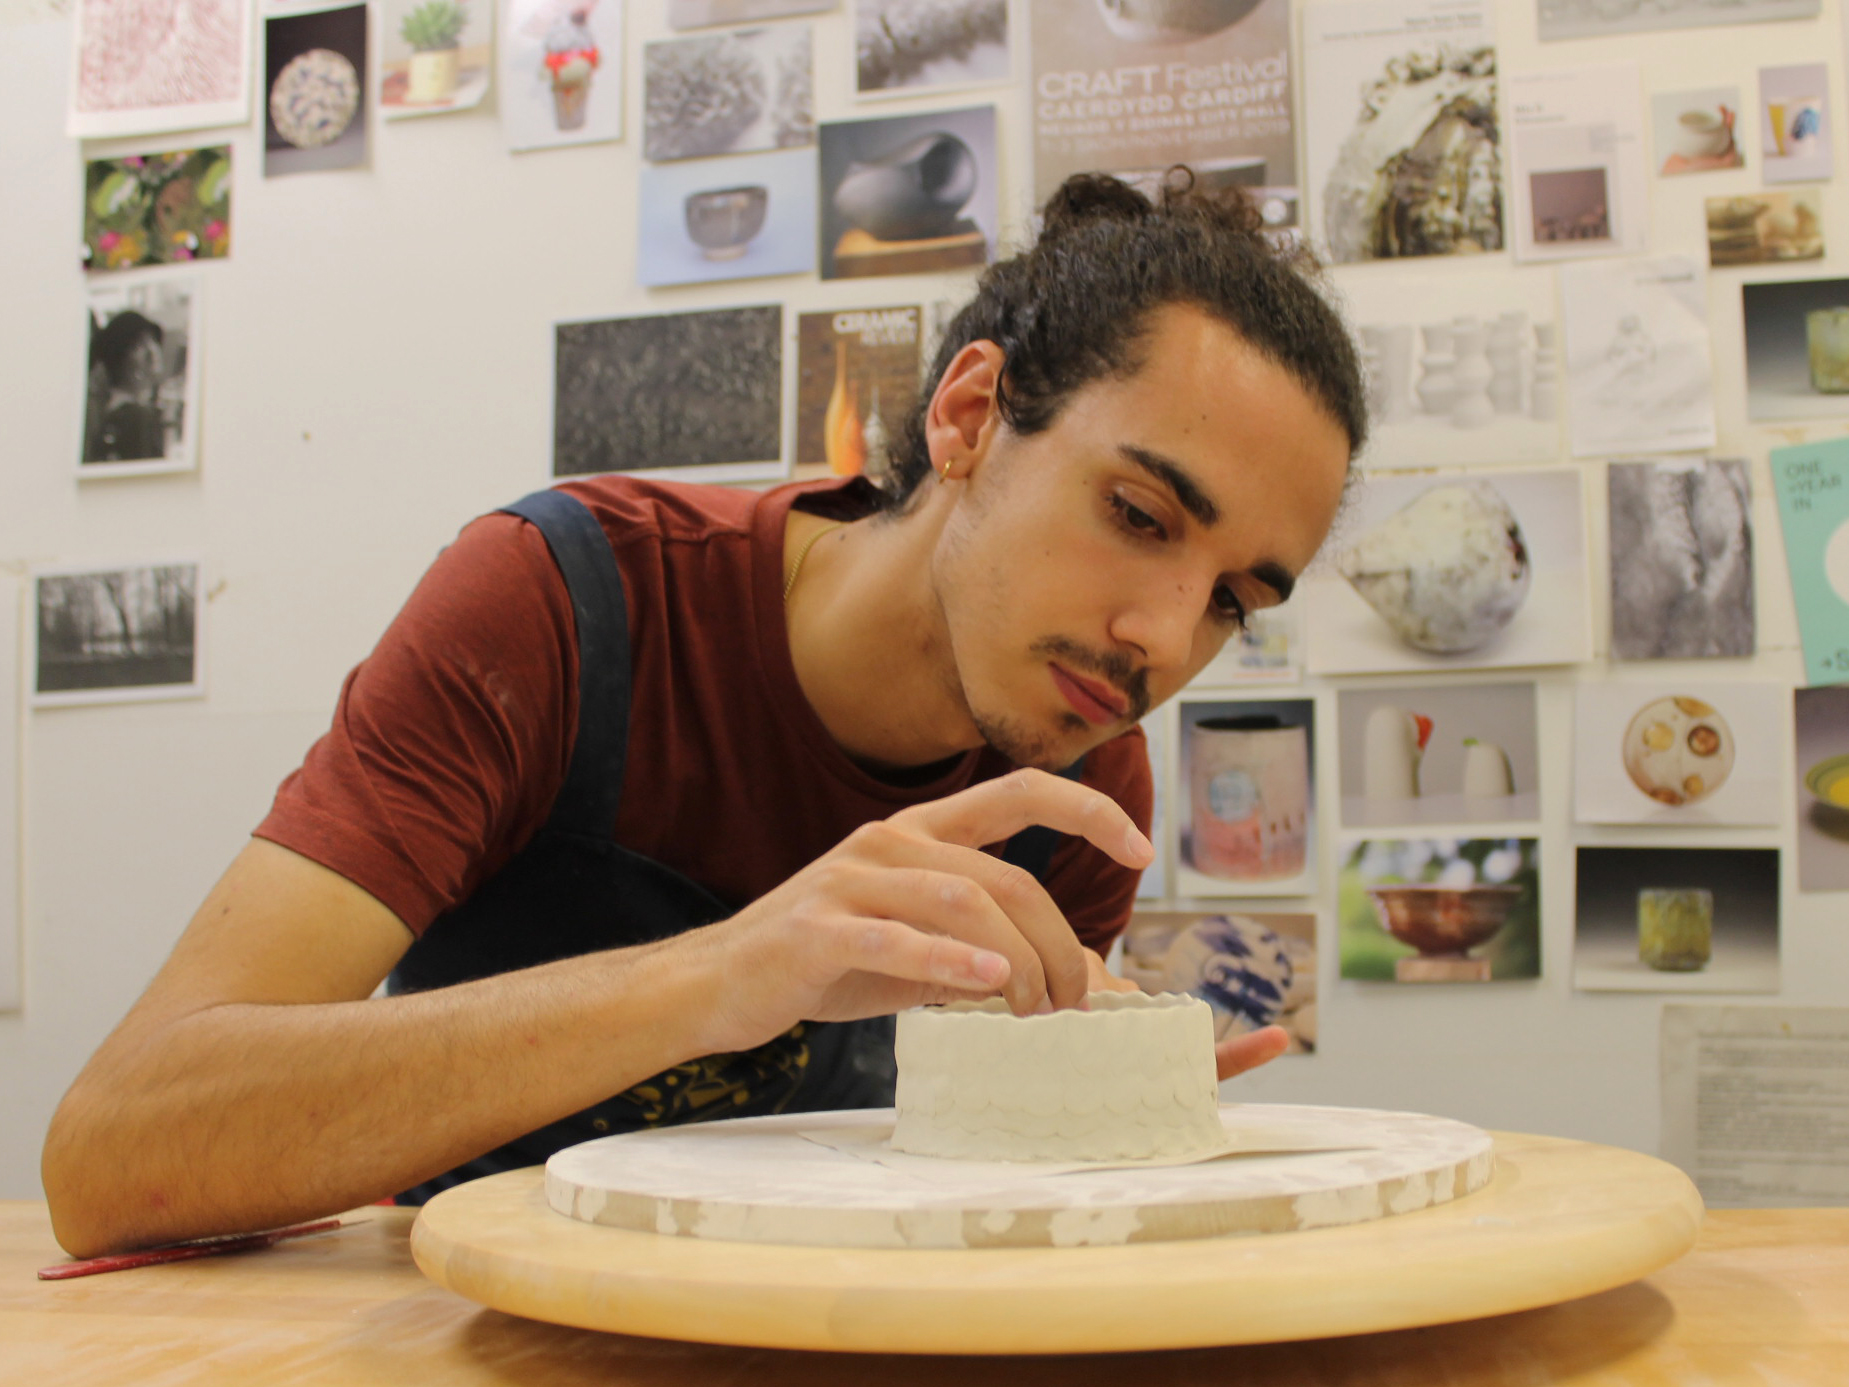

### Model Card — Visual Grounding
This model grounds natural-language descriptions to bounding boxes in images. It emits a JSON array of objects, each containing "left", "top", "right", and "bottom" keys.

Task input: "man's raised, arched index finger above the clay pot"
[{"left": 888, "top": 769, "right": 1156, "bottom": 867}]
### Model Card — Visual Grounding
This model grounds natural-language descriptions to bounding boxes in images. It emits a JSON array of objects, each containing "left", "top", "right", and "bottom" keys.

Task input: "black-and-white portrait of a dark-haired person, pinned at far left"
[{"left": 78, "top": 274, "right": 200, "bottom": 477}]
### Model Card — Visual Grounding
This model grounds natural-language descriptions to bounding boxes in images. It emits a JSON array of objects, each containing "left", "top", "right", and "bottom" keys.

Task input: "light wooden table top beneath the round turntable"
[{"left": 0, "top": 1202, "right": 1849, "bottom": 1387}]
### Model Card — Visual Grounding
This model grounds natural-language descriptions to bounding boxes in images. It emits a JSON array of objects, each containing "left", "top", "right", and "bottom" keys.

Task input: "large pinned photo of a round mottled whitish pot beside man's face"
[{"left": 1302, "top": 468, "right": 1592, "bottom": 675}]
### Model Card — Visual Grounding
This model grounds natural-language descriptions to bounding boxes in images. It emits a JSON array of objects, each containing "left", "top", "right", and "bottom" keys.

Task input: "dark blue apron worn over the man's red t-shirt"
[{"left": 386, "top": 490, "right": 1080, "bottom": 1204}]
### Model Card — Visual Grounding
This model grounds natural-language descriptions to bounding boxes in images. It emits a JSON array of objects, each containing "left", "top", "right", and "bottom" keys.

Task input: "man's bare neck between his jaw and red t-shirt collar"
[{"left": 784, "top": 505, "right": 982, "bottom": 775}]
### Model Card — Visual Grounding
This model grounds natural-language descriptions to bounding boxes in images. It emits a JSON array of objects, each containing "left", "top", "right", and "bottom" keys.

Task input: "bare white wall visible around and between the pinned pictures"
[{"left": 0, "top": 0, "right": 1849, "bottom": 1198}]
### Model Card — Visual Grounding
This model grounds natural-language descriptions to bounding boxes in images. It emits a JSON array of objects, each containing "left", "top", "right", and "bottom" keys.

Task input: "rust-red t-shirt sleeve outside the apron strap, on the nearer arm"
[{"left": 255, "top": 514, "right": 577, "bottom": 934}]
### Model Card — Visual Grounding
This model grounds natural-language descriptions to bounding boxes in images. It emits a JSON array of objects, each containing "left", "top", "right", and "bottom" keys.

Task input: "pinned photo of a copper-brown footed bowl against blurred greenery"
[{"left": 1337, "top": 838, "right": 1540, "bottom": 982}]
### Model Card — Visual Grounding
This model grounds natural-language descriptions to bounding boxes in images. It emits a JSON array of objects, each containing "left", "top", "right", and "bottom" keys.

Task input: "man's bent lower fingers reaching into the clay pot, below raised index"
[{"left": 852, "top": 821, "right": 1089, "bottom": 1015}]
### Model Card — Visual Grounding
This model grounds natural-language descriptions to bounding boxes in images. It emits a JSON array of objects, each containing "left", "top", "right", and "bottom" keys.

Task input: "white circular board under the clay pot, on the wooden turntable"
[{"left": 545, "top": 1104, "right": 1494, "bottom": 1248}]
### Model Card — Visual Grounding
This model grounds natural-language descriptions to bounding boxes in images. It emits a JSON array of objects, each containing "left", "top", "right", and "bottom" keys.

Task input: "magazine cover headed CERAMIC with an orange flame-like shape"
[{"left": 797, "top": 303, "right": 923, "bottom": 477}]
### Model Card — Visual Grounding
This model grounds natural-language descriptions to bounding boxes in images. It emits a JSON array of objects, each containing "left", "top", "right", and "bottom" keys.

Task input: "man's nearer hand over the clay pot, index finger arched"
[{"left": 684, "top": 771, "right": 1156, "bottom": 1052}]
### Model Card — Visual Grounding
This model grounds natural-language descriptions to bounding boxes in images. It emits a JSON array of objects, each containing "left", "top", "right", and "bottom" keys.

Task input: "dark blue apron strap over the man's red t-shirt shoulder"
[{"left": 501, "top": 490, "right": 629, "bottom": 841}]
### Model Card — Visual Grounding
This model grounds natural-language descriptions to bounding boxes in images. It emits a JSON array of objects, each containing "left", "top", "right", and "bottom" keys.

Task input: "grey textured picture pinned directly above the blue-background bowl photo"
[{"left": 642, "top": 24, "right": 815, "bottom": 163}]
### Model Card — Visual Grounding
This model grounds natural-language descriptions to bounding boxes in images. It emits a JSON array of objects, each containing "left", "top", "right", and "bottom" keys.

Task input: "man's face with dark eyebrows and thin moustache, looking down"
[{"left": 926, "top": 307, "right": 1348, "bottom": 769}]
